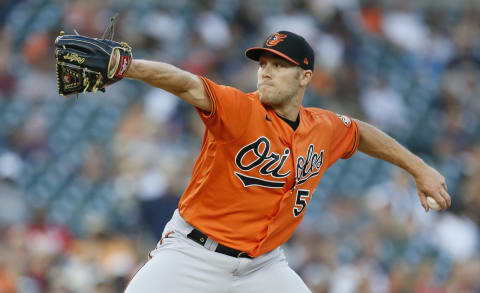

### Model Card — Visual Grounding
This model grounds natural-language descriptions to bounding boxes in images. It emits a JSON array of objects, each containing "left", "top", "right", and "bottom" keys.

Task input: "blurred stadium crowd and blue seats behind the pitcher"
[{"left": 0, "top": 0, "right": 480, "bottom": 293}]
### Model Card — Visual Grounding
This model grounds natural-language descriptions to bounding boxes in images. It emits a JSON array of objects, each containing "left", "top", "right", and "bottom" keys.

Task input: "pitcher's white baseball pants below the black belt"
[{"left": 125, "top": 210, "right": 310, "bottom": 293}]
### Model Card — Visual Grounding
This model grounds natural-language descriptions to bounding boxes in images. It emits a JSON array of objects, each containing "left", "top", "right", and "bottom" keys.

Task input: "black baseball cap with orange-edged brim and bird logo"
[{"left": 245, "top": 31, "right": 315, "bottom": 71}]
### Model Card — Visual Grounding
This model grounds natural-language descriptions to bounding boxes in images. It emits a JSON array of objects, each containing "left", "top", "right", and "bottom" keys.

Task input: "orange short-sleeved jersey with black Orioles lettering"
[{"left": 179, "top": 77, "right": 359, "bottom": 257}]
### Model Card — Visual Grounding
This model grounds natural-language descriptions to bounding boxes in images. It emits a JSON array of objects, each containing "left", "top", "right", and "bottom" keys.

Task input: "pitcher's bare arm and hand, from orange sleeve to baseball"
[{"left": 355, "top": 119, "right": 451, "bottom": 211}]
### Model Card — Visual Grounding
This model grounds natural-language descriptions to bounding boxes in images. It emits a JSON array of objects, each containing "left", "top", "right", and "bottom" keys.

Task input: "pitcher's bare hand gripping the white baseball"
[{"left": 413, "top": 163, "right": 452, "bottom": 212}]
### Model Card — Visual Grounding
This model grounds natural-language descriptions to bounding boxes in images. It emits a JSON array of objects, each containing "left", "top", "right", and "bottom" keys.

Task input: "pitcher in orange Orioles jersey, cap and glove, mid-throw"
[{"left": 56, "top": 26, "right": 450, "bottom": 293}]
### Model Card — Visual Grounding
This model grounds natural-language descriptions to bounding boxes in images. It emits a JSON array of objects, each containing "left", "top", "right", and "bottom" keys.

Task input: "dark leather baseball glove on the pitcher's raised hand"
[{"left": 55, "top": 16, "right": 132, "bottom": 96}]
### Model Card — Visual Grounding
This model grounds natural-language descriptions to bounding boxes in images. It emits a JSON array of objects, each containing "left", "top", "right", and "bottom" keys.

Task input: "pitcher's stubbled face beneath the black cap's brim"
[{"left": 257, "top": 53, "right": 300, "bottom": 106}]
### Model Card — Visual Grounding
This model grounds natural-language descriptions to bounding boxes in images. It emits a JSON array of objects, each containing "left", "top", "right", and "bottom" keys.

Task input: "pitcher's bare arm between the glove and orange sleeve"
[{"left": 125, "top": 59, "right": 210, "bottom": 112}]
